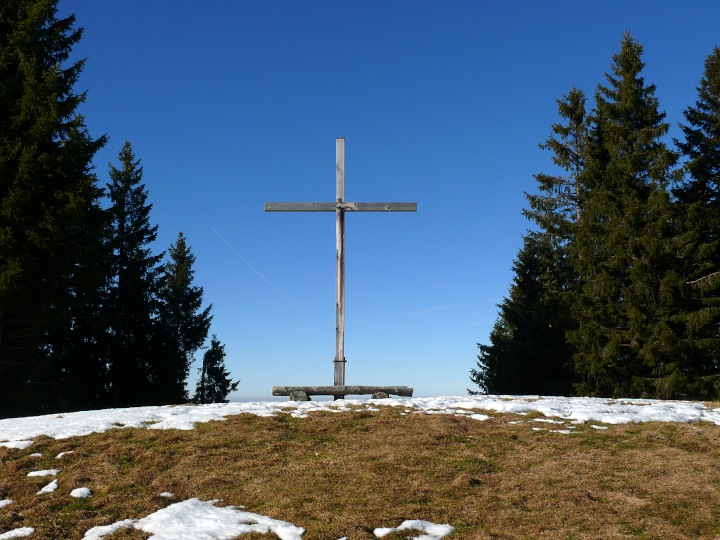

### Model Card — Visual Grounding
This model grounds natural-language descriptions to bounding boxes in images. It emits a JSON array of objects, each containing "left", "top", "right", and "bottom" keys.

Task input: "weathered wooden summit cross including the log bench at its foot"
[{"left": 265, "top": 138, "right": 417, "bottom": 399}]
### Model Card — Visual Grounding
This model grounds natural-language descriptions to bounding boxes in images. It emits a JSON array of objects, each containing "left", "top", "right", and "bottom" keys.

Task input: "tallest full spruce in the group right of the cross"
[{"left": 569, "top": 34, "right": 682, "bottom": 397}]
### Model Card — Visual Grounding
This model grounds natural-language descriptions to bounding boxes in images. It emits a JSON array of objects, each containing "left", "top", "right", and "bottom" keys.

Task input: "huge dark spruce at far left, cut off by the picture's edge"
[{"left": 0, "top": 0, "right": 105, "bottom": 415}]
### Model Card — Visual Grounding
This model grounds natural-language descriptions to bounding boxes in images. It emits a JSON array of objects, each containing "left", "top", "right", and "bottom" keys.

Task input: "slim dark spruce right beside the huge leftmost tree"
[{"left": 107, "top": 142, "right": 163, "bottom": 406}]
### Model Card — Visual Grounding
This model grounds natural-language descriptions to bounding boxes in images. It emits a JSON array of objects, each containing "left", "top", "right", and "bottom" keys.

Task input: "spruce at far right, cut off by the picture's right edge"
[{"left": 674, "top": 47, "right": 720, "bottom": 400}]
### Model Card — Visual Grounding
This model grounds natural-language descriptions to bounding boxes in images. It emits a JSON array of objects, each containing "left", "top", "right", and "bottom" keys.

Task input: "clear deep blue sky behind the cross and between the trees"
[{"left": 59, "top": 0, "right": 720, "bottom": 400}]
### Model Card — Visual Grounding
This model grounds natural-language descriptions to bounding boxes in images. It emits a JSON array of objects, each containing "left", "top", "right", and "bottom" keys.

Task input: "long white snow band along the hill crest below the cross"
[{"left": 0, "top": 396, "right": 720, "bottom": 449}]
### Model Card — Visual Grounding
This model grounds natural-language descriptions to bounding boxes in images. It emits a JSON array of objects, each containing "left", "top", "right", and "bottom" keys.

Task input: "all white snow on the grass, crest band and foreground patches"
[{"left": 0, "top": 396, "right": 720, "bottom": 540}]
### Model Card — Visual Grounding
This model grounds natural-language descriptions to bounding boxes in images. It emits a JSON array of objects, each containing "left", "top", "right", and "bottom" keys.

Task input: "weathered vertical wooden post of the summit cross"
[{"left": 333, "top": 138, "right": 345, "bottom": 392}]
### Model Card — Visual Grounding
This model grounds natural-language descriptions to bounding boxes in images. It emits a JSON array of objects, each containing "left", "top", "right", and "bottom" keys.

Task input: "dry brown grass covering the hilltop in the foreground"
[{"left": 0, "top": 408, "right": 720, "bottom": 540}]
